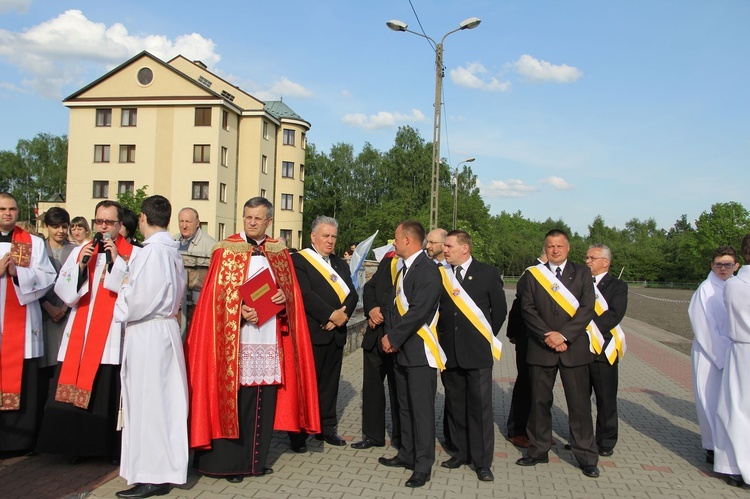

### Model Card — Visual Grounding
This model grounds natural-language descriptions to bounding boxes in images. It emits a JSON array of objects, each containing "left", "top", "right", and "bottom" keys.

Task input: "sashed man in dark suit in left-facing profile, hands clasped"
[{"left": 378, "top": 220, "right": 444, "bottom": 487}]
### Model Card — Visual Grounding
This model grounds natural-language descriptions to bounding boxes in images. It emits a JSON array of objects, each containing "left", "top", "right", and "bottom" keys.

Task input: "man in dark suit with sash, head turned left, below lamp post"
[{"left": 438, "top": 230, "right": 507, "bottom": 482}]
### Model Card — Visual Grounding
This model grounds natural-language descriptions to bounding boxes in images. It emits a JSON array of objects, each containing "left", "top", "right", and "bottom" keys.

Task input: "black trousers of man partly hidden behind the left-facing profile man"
[{"left": 362, "top": 345, "right": 401, "bottom": 448}]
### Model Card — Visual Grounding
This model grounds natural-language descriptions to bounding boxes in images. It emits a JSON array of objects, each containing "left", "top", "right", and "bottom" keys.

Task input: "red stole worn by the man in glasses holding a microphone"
[{"left": 55, "top": 237, "right": 133, "bottom": 409}]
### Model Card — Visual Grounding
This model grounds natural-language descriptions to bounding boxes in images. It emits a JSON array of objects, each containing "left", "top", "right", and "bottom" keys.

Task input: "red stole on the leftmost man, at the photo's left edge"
[{"left": 0, "top": 227, "right": 32, "bottom": 411}]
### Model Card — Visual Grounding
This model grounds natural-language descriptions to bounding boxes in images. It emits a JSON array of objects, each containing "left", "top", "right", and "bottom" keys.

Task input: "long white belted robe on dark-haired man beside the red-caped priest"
[{"left": 115, "top": 232, "right": 188, "bottom": 484}]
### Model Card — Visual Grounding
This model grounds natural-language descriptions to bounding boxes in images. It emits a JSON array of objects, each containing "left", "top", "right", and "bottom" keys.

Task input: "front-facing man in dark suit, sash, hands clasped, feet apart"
[{"left": 516, "top": 229, "right": 599, "bottom": 478}]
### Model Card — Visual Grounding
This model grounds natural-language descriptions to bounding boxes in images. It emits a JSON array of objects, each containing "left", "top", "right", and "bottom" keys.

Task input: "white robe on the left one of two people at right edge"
[{"left": 688, "top": 272, "right": 730, "bottom": 450}]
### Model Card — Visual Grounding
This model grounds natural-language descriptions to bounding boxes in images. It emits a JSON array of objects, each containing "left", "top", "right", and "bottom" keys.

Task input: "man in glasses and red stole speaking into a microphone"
[{"left": 37, "top": 200, "right": 140, "bottom": 464}]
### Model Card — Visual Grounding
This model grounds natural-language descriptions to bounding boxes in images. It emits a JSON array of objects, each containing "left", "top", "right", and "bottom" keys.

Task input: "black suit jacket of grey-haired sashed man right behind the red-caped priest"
[{"left": 292, "top": 253, "right": 359, "bottom": 346}]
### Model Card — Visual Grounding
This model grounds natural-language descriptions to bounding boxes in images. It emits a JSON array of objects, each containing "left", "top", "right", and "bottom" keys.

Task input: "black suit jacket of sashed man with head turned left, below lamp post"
[{"left": 438, "top": 260, "right": 508, "bottom": 369}]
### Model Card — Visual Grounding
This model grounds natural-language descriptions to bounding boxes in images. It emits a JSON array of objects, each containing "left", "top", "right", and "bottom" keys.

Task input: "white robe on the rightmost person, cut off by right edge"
[{"left": 714, "top": 266, "right": 750, "bottom": 483}]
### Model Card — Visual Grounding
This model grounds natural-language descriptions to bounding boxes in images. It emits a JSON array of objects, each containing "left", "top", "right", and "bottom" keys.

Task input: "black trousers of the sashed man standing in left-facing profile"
[{"left": 394, "top": 363, "right": 437, "bottom": 473}]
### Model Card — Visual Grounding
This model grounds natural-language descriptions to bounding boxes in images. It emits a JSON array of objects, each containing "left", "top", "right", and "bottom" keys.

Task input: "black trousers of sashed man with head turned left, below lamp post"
[{"left": 441, "top": 367, "right": 495, "bottom": 468}]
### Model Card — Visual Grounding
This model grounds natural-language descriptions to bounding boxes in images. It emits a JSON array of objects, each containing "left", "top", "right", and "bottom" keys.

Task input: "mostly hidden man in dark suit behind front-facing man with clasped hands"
[{"left": 506, "top": 249, "right": 547, "bottom": 449}]
